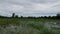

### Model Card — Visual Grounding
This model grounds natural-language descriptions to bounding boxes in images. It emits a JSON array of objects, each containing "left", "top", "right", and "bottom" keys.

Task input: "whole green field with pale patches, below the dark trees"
[{"left": 0, "top": 18, "right": 60, "bottom": 34}]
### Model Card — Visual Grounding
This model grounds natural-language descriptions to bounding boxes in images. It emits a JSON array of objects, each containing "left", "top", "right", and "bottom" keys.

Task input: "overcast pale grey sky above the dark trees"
[{"left": 0, "top": 0, "right": 60, "bottom": 16}]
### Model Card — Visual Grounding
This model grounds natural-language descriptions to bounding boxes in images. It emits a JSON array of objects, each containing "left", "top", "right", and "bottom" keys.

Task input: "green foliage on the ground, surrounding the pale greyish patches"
[{"left": 0, "top": 18, "right": 60, "bottom": 34}]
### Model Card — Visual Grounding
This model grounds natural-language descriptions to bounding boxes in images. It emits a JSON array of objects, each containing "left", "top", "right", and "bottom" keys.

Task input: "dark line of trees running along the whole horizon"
[{"left": 0, "top": 13, "right": 60, "bottom": 19}]
